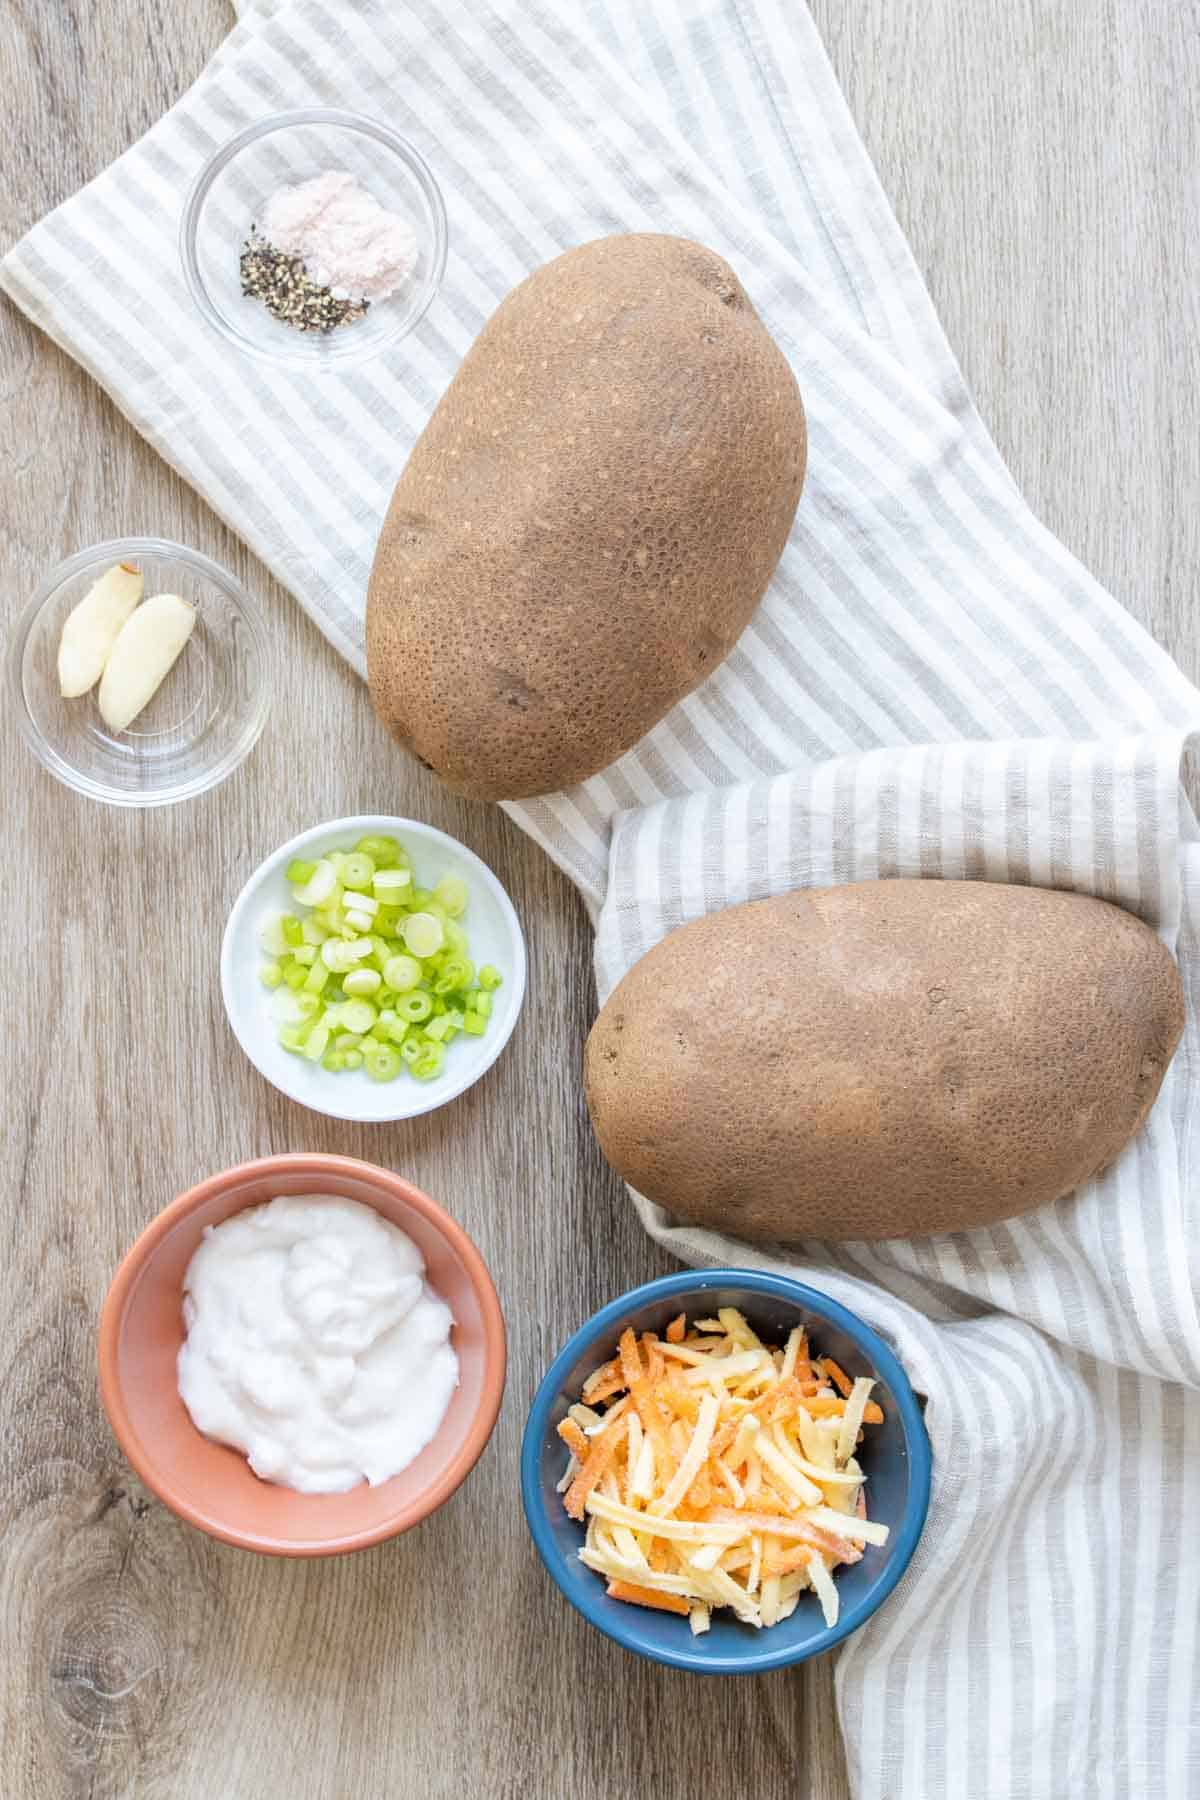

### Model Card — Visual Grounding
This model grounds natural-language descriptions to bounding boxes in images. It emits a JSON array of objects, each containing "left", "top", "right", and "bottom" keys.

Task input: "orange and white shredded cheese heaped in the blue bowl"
[{"left": 558, "top": 1307, "right": 887, "bottom": 1636}]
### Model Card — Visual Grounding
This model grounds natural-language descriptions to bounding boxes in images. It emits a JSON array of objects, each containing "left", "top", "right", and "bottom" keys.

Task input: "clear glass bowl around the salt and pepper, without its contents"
[{"left": 180, "top": 106, "right": 446, "bottom": 369}]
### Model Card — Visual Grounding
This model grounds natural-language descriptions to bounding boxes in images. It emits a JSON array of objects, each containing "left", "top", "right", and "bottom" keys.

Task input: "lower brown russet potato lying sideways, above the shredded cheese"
[{"left": 585, "top": 880, "right": 1184, "bottom": 1244}]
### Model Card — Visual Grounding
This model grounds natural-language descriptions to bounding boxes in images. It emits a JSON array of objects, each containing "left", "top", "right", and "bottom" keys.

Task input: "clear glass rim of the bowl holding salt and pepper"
[{"left": 178, "top": 106, "right": 450, "bottom": 373}]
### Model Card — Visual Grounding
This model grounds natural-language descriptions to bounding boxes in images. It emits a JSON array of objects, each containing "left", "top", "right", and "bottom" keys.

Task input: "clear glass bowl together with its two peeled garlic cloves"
[{"left": 9, "top": 538, "right": 268, "bottom": 806}]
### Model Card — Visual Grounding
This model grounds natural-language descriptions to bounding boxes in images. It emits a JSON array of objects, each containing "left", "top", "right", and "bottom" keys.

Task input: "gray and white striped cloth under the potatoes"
[{"left": 0, "top": 0, "right": 1200, "bottom": 1800}]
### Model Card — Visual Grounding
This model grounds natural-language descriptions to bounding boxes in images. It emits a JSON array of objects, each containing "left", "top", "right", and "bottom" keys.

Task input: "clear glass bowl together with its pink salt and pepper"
[{"left": 180, "top": 108, "right": 446, "bottom": 369}]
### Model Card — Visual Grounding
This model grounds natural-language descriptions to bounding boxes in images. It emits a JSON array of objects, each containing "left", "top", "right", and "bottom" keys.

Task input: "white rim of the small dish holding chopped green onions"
[{"left": 221, "top": 812, "right": 529, "bottom": 1125}]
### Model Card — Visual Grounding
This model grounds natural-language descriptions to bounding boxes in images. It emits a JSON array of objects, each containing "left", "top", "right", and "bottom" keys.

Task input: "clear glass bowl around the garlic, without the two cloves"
[{"left": 9, "top": 538, "right": 268, "bottom": 806}]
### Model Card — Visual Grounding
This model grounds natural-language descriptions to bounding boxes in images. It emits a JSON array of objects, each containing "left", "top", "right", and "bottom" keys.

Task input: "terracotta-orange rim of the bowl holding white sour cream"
[{"left": 97, "top": 1150, "right": 507, "bottom": 1557}]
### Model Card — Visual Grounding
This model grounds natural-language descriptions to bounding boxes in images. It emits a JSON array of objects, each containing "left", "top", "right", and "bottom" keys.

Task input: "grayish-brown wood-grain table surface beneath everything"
[{"left": 0, "top": 0, "right": 1200, "bottom": 1800}]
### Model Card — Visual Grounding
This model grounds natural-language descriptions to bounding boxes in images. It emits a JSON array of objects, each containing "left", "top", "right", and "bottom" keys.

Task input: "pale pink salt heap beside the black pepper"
[{"left": 259, "top": 169, "right": 417, "bottom": 301}]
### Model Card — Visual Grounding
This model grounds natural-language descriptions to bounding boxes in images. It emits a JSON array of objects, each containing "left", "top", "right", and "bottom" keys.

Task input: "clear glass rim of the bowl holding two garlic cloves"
[{"left": 7, "top": 536, "right": 270, "bottom": 810}]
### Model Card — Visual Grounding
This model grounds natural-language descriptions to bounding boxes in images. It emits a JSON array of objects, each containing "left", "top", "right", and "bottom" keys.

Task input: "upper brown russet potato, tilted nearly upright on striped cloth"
[{"left": 367, "top": 234, "right": 806, "bottom": 799}]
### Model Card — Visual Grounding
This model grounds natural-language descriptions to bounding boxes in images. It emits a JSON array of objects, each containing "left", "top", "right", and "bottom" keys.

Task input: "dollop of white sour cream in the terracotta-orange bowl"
[{"left": 178, "top": 1193, "right": 459, "bottom": 1494}]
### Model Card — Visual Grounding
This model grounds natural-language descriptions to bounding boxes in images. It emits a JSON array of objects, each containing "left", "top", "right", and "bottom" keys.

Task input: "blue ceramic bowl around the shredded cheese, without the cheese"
[{"left": 522, "top": 1269, "right": 930, "bottom": 1676}]
